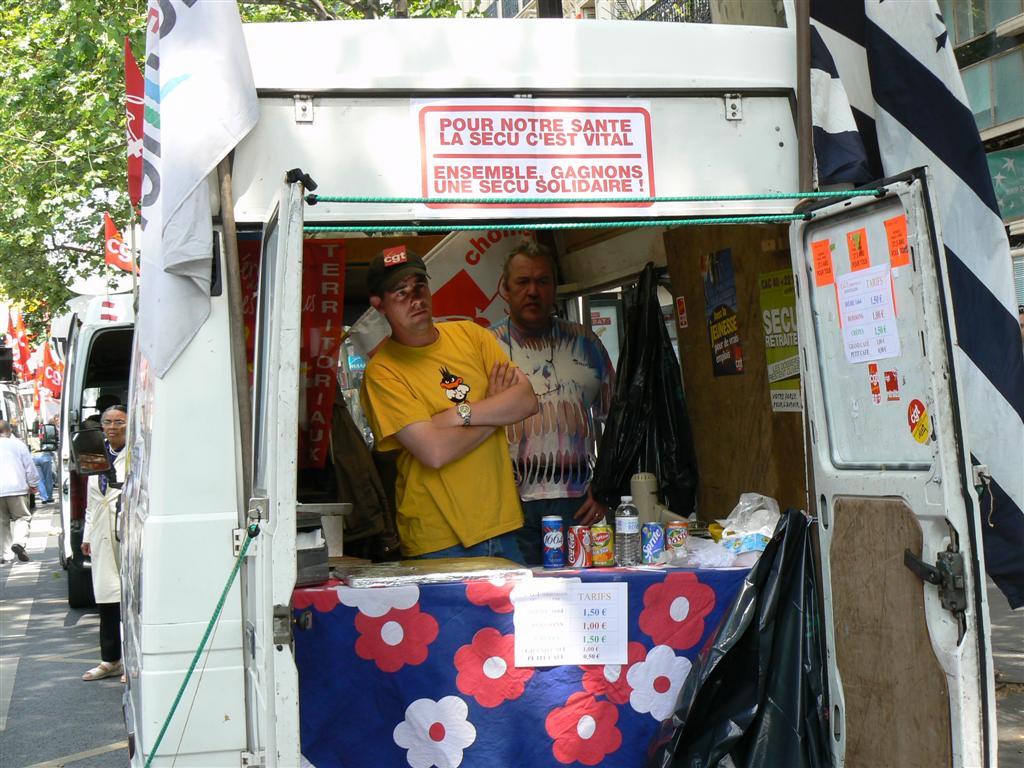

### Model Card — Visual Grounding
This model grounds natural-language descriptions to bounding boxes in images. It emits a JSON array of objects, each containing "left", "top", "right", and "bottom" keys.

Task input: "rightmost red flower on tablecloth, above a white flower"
[{"left": 640, "top": 571, "right": 715, "bottom": 650}]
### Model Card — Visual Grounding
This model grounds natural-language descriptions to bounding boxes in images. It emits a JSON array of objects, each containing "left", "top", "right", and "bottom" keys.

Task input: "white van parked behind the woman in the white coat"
[{"left": 58, "top": 294, "right": 135, "bottom": 608}]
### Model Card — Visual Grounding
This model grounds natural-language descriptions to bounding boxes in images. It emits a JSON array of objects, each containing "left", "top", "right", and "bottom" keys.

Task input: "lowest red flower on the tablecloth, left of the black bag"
[{"left": 544, "top": 691, "right": 623, "bottom": 765}]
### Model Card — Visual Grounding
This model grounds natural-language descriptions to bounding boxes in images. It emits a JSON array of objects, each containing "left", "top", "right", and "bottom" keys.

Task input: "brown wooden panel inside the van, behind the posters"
[{"left": 665, "top": 224, "right": 807, "bottom": 520}]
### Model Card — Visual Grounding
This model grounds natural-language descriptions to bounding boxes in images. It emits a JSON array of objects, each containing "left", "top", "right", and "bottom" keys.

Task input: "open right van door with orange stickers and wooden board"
[{"left": 791, "top": 170, "right": 994, "bottom": 768}]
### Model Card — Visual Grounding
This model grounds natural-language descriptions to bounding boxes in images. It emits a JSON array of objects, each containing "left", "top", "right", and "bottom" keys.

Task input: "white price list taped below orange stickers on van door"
[{"left": 836, "top": 265, "right": 900, "bottom": 362}]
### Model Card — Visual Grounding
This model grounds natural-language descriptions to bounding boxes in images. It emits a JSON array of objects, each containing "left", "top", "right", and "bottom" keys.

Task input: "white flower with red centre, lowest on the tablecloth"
[{"left": 394, "top": 696, "right": 476, "bottom": 768}]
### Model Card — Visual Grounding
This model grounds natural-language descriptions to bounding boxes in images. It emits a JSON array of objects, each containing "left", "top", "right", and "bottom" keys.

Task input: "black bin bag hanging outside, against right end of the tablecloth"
[{"left": 647, "top": 509, "right": 833, "bottom": 768}]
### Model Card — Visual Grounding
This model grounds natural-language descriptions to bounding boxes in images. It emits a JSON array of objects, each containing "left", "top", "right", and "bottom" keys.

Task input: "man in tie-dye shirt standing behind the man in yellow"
[{"left": 492, "top": 241, "right": 614, "bottom": 565}]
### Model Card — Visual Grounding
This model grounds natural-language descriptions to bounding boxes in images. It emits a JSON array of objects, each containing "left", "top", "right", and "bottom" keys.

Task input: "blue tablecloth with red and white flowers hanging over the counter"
[{"left": 294, "top": 568, "right": 746, "bottom": 768}]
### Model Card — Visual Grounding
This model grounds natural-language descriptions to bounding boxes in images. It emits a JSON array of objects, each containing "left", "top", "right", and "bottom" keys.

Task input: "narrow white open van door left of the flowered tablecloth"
[{"left": 242, "top": 183, "right": 303, "bottom": 766}]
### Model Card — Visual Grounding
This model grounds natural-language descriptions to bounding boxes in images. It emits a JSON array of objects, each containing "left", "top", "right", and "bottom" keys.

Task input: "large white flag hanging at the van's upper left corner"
[{"left": 138, "top": 0, "right": 259, "bottom": 378}]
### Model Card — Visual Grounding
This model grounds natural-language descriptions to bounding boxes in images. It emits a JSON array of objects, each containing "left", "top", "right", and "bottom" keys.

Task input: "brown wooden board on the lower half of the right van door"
[{"left": 830, "top": 498, "right": 952, "bottom": 768}]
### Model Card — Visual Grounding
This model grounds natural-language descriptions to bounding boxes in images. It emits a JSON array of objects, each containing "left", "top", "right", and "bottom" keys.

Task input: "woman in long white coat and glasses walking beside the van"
[{"left": 82, "top": 406, "right": 128, "bottom": 680}]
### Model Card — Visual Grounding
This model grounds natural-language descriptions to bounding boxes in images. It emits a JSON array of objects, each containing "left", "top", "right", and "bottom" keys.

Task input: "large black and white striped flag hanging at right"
[{"left": 811, "top": 0, "right": 1024, "bottom": 607}]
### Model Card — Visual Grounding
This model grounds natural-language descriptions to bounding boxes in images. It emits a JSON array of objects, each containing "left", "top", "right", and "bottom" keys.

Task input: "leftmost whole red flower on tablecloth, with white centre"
[{"left": 355, "top": 605, "right": 437, "bottom": 672}]
